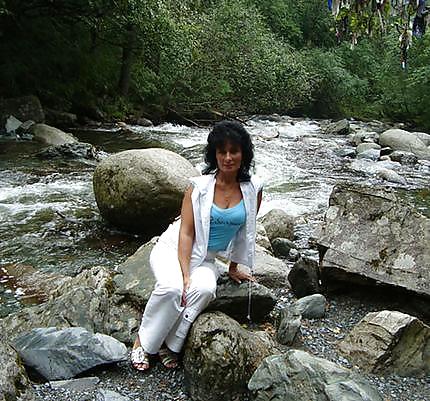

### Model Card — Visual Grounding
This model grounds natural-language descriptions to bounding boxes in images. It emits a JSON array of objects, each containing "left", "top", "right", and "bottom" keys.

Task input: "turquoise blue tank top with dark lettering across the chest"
[{"left": 208, "top": 199, "right": 246, "bottom": 251}]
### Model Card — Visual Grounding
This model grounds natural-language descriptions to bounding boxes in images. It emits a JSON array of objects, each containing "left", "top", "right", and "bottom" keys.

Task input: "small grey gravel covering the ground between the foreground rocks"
[{"left": 34, "top": 293, "right": 430, "bottom": 401}]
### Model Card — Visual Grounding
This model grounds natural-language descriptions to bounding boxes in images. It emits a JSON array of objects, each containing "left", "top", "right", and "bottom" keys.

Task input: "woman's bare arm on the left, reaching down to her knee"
[{"left": 178, "top": 187, "right": 195, "bottom": 306}]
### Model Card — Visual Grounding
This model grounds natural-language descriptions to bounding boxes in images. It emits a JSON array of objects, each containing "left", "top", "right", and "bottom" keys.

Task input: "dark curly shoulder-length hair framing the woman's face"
[{"left": 203, "top": 121, "right": 254, "bottom": 181}]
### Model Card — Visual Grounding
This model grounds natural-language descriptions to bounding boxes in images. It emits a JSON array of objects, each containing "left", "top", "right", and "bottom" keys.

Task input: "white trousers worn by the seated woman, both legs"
[{"left": 139, "top": 241, "right": 219, "bottom": 354}]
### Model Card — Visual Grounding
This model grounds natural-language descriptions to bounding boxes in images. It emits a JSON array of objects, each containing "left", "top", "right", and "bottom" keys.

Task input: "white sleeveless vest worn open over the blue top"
[{"left": 159, "top": 174, "right": 263, "bottom": 268}]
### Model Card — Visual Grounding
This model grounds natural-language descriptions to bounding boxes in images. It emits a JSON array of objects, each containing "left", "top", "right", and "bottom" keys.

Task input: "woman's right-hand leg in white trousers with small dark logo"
[{"left": 165, "top": 260, "right": 218, "bottom": 352}]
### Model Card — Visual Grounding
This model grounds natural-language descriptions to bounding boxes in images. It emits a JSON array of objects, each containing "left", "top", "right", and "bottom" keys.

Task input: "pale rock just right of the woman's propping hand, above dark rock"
[{"left": 253, "top": 245, "right": 290, "bottom": 288}]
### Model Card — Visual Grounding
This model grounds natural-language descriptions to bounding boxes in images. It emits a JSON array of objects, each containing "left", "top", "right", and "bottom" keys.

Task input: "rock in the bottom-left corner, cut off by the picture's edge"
[{"left": 0, "top": 335, "right": 36, "bottom": 401}]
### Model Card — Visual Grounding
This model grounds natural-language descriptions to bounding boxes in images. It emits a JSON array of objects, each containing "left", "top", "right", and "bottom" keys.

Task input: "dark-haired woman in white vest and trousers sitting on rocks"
[{"left": 131, "top": 121, "right": 262, "bottom": 371}]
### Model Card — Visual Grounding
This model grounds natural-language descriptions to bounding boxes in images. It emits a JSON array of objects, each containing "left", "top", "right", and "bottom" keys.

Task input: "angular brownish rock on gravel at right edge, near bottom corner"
[{"left": 339, "top": 310, "right": 430, "bottom": 376}]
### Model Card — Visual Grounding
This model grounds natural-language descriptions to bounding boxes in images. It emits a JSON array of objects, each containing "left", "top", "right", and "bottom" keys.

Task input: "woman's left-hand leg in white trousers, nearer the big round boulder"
[{"left": 139, "top": 242, "right": 184, "bottom": 354}]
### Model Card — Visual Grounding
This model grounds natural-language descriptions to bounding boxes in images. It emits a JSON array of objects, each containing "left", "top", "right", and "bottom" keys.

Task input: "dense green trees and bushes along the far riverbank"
[{"left": 0, "top": 0, "right": 430, "bottom": 129}]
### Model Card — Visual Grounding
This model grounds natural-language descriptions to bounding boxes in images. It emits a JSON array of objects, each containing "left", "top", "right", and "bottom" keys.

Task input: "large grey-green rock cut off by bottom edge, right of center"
[{"left": 248, "top": 350, "right": 383, "bottom": 401}]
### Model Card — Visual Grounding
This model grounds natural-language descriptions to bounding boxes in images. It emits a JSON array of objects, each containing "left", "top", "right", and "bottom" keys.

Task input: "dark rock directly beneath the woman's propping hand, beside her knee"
[{"left": 207, "top": 275, "right": 277, "bottom": 322}]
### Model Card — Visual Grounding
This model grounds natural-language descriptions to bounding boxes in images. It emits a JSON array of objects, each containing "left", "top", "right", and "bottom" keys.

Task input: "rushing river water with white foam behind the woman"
[{"left": 0, "top": 117, "right": 430, "bottom": 317}]
